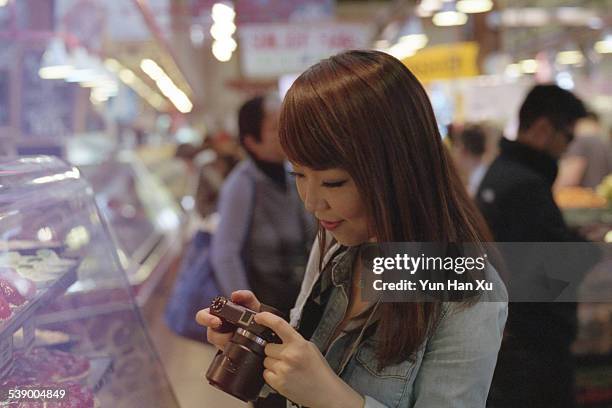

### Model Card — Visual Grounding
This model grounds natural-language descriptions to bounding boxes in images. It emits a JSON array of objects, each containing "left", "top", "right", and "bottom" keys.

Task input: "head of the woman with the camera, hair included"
[{"left": 280, "top": 51, "right": 486, "bottom": 245}]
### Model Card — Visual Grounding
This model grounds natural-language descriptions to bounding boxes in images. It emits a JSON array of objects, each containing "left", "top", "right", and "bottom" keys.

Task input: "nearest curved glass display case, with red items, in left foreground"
[{"left": 0, "top": 156, "right": 177, "bottom": 408}]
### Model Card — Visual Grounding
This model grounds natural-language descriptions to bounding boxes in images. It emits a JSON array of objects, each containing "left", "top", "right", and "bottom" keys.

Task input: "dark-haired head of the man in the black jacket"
[{"left": 518, "top": 85, "right": 587, "bottom": 158}]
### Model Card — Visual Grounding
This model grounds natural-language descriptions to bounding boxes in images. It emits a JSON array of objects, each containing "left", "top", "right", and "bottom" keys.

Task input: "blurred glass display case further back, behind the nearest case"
[{"left": 79, "top": 151, "right": 184, "bottom": 305}]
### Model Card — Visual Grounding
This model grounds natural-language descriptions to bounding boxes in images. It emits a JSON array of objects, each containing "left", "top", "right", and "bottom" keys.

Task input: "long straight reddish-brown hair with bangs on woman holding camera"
[{"left": 279, "top": 51, "right": 490, "bottom": 366}]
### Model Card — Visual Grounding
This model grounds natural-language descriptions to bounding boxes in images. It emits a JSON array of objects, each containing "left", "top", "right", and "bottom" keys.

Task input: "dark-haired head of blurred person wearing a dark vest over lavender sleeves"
[{"left": 238, "top": 96, "right": 285, "bottom": 163}]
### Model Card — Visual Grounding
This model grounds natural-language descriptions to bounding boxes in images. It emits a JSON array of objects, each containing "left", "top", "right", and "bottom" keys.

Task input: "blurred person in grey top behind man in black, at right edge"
[{"left": 555, "top": 112, "right": 612, "bottom": 188}]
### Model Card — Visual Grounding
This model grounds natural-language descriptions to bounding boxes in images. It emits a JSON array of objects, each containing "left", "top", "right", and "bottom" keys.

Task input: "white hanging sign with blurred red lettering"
[{"left": 239, "top": 23, "right": 372, "bottom": 78}]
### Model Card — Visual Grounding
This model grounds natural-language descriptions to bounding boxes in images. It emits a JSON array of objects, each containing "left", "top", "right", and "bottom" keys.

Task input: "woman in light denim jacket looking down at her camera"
[{"left": 196, "top": 51, "right": 507, "bottom": 408}]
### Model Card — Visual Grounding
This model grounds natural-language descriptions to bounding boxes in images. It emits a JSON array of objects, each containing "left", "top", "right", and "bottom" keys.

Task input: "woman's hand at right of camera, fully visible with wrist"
[{"left": 255, "top": 312, "right": 364, "bottom": 408}]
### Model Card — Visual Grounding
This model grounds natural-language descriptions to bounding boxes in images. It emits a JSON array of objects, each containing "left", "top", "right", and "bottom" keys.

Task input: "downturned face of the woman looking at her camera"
[{"left": 292, "top": 164, "right": 371, "bottom": 246}]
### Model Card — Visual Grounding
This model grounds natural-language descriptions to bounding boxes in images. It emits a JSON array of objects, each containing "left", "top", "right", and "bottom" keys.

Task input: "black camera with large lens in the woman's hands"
[{"left": 206, "top": 296, "right": 281, "bottom": 402}]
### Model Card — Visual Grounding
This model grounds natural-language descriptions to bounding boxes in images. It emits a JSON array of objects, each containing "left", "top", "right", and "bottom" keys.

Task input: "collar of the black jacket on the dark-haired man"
[{"left": 499, "top": 138, "right": 559, "bottom": 186}]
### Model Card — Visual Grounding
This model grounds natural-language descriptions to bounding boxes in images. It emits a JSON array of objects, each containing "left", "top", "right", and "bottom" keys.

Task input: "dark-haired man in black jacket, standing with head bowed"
[{"left": 476, "top": 85, "right": 586, "bottom": 408}]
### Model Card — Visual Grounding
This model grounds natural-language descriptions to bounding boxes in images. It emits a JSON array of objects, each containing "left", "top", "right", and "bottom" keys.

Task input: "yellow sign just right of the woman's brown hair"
[{"left": 402, "top": 42, "right": 478, "bottom": 83}]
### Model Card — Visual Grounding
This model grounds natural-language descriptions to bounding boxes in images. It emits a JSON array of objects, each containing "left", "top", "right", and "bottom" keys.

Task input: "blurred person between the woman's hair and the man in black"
[{"left": 452, "top": 124, "right": 487, "bottom": 197}]
